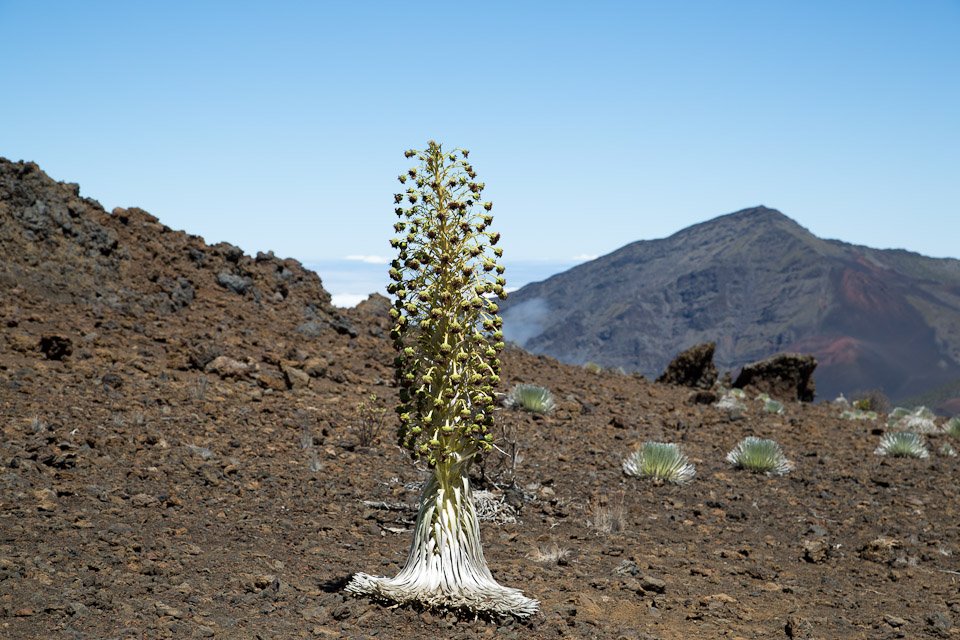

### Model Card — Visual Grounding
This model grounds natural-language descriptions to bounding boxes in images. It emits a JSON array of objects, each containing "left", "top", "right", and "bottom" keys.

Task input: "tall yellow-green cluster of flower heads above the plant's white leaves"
[{"left": 388, "top": 140, "right": 506, "bottom": 465}]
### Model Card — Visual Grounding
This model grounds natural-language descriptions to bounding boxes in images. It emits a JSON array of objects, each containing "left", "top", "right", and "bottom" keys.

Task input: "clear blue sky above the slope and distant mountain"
[{"left": 0, "top": 0, "right": 960, "bottom": 304}]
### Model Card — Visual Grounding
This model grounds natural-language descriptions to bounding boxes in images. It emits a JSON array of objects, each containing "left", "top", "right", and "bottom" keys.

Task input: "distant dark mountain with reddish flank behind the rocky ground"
[{"left": 503, "top": 206, "right": 960, "bottom": 400}]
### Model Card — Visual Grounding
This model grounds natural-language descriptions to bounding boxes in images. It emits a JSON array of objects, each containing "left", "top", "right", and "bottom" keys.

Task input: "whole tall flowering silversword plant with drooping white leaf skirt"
[{"left": 346, "top": 140, "right": 539, "bottom": 617}]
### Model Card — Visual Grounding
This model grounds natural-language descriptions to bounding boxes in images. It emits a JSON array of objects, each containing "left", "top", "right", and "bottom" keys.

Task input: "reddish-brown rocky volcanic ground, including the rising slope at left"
[{"left": 0, "top": 163, "right": 960, "bottom": 639}]
